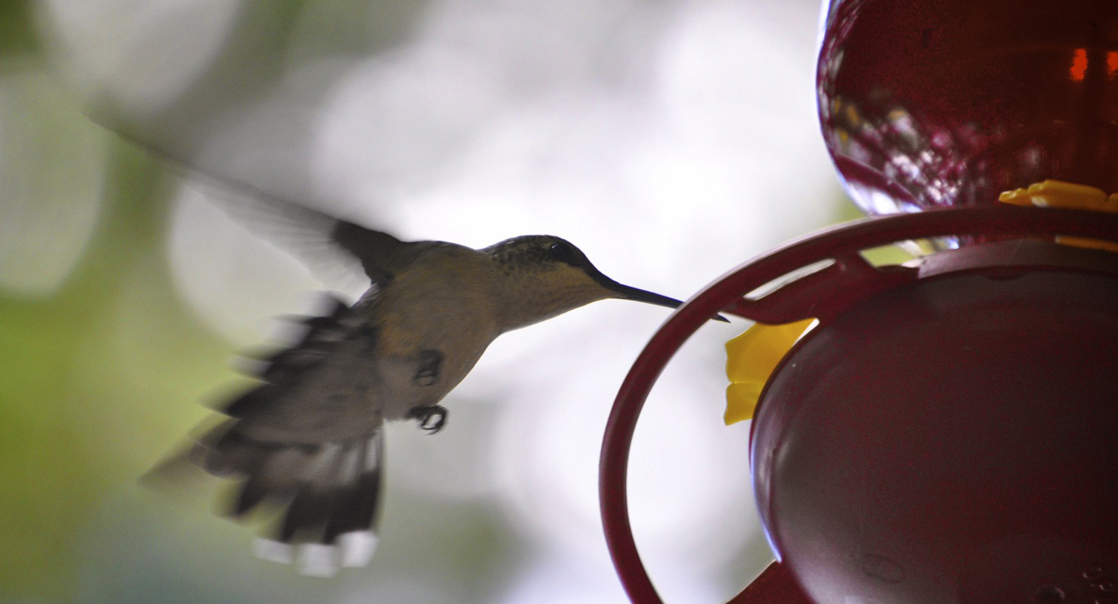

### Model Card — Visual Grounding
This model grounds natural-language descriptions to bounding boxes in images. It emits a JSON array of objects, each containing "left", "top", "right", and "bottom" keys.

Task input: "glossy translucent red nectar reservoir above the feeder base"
[{"left": 817, "top": 0, "right": 1118, "bottom": 214}]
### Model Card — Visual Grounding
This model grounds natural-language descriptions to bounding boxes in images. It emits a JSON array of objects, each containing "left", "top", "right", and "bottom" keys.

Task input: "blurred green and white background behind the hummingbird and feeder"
[{"left": 0, "top": 0, "right": 854, "bottom": 604}]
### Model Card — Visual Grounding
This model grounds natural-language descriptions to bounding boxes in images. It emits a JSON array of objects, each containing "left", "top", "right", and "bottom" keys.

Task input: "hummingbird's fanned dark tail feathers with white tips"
[{"left": 153, "top": 302, "right": 385, "bottom": 575}]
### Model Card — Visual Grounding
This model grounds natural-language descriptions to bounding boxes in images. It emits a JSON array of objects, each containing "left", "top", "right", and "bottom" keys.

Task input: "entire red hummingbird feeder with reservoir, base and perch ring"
[{"left": 600, "top": 0, "right": 1118, "bottom": 604}]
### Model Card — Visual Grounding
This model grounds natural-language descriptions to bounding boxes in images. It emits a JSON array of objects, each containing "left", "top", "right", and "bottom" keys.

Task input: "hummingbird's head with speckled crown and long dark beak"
[{"left": 483, "top": 235, "right": 682, "bottom": 329}]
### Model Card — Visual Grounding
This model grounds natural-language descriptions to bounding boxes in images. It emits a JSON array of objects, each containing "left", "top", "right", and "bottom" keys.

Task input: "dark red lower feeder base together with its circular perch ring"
[{"left": 600, "top": 207, "right": 1118, "bottom": 604}]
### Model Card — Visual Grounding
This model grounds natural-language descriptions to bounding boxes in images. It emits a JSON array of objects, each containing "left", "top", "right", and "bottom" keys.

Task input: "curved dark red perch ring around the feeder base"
[{"left": 599, "top": 206, "right": 1118, "bottom": 603}]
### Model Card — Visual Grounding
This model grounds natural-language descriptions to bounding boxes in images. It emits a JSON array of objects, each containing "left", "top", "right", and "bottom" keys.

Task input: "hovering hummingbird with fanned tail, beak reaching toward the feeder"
[{"left": 155, "top": 195, "right": 724, "bottom": 575}]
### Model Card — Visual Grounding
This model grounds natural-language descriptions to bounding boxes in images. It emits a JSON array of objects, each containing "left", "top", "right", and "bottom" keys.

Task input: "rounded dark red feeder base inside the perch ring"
[{"left": 750, "top": 242, "right": 1118, "bottom": 604}]
